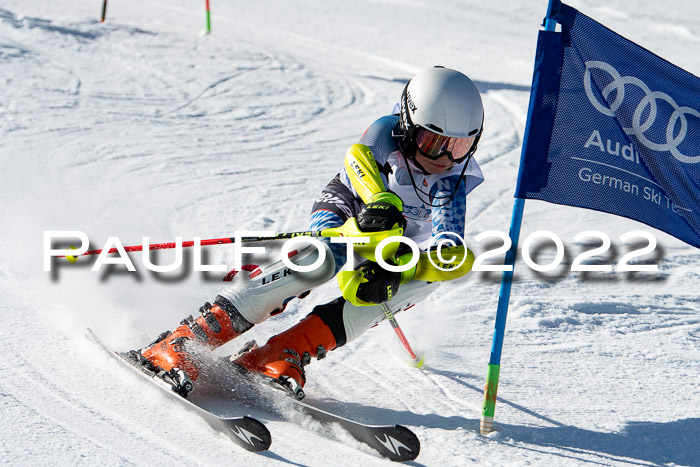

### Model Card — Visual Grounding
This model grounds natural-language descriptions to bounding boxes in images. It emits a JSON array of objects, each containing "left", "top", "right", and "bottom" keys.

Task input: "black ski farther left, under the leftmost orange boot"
[{"left": 87, "top": 329, "right": 272, "bottom": 452}]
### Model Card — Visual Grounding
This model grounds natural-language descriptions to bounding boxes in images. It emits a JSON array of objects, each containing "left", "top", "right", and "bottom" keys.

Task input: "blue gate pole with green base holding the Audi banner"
[{"left": 479, "top": 0, "right": 561, "bottom": 435}]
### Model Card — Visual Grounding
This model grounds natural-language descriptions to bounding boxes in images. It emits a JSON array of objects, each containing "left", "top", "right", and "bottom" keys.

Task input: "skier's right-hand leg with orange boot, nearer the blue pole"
[{"left": 235, "top": 281, "right": 439, "bottom": 391}]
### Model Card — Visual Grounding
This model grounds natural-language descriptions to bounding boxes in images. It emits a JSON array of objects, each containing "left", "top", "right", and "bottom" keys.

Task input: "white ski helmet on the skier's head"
[{"left": 399, "top": 66, "right": 484, "bottom": 163}]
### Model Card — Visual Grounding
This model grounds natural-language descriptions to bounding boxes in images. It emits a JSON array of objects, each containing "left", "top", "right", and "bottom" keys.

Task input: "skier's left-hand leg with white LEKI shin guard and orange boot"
[{"left": 129, "top": 177, "right": 357, "bottom": 392}]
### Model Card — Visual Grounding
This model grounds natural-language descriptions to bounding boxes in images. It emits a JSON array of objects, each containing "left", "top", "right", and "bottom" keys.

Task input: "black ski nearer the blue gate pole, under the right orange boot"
[{"left": 290, "top": 399, "right": 420, "bottom": 462}]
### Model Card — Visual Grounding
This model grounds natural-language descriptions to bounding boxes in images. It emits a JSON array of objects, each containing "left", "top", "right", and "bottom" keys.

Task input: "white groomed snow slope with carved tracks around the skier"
[{"left": 0, "top": 0, "right": 700, "bottom": 466}]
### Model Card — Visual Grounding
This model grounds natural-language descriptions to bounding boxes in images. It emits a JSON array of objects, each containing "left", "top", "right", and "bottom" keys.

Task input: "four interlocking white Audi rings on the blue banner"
[{"left": 583, "top": 60, "right": 700, "bottom": 164}]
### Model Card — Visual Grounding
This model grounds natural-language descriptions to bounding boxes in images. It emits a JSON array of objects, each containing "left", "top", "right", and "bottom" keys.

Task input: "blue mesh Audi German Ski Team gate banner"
[{"left": 515, "top": 4, "right": 700, "bottom": 248}]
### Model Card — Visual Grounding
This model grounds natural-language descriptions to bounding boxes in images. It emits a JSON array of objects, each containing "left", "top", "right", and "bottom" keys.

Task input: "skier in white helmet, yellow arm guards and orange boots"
[{"left": 127, "top": 67, "right": 484, "bottom": 396}]
